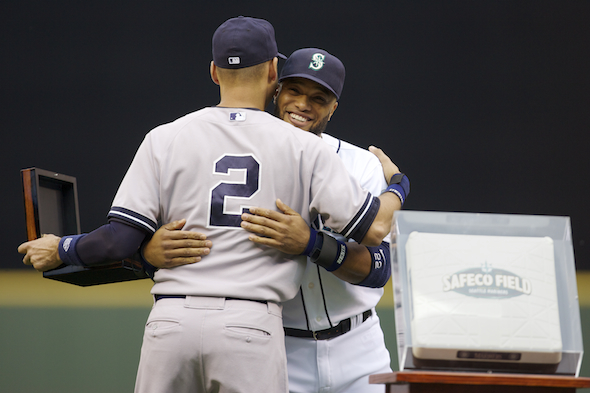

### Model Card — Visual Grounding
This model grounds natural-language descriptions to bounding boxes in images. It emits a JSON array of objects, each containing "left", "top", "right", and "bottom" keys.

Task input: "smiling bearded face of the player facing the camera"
[{"left": 275, "top": 78, "right": 338, "bottom": 135}]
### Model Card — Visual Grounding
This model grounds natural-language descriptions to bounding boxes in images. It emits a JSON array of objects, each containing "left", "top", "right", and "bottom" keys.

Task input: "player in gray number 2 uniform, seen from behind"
[{"left": 19, "top": 17, "right": 408, "bottom": 393}]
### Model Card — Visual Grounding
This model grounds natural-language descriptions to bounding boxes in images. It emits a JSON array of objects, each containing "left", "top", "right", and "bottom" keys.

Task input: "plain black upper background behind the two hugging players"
[{"left": 0, "top": 0, "right": 590, "bottom": 269}]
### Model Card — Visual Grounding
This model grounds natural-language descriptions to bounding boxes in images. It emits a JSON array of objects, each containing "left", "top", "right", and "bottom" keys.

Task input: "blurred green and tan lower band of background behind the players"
[{"left": 0, "top": 270, "right": 590, "bottom": 393}]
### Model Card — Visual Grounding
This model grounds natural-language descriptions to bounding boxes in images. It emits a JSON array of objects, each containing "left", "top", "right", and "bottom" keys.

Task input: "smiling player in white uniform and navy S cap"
[{"left": 144, "top": 48, "right": 409, "bottom": 393}]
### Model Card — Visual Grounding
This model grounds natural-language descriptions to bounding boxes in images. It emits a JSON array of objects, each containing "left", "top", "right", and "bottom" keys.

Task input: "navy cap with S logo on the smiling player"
[{"left": 279, "top": 48, "right": 345, "bottom": 99}]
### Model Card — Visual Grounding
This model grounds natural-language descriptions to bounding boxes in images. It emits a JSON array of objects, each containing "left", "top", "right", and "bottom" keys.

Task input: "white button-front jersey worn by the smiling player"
[{"left": 283, "top": 133, "right": 389, "bottom": 331}]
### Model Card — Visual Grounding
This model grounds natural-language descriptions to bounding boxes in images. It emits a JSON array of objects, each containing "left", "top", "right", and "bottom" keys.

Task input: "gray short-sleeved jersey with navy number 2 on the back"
[{"left": 109, "top": 107, "right": 379, "bottom": 302}]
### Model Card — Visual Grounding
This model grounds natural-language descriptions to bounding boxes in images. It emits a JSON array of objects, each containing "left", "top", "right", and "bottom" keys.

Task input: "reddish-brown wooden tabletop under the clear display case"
[{"left": 369, "top": 371, "right": 590, "bottom": 393}]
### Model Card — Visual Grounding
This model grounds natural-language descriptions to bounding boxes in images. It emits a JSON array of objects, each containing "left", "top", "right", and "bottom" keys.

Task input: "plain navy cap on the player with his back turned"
[{"left": 213, "top": 16, "right": 287, "bottom": 69}]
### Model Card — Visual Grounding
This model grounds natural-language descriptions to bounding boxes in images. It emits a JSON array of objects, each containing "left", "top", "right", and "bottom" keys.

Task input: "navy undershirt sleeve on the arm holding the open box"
[{"left": 59, "top": 221, "right": 147, "bottom": 266}]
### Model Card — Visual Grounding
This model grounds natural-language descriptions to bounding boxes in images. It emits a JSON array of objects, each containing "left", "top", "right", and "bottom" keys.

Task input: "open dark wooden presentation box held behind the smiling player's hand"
[{"left": 21, "top": 168, "right": 149, "bottom": 287}]
